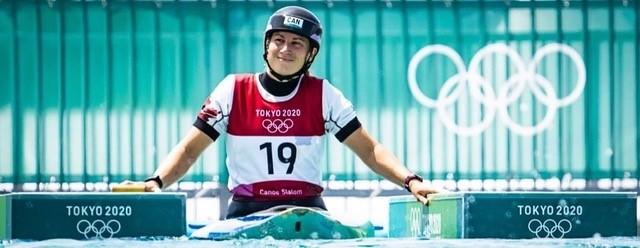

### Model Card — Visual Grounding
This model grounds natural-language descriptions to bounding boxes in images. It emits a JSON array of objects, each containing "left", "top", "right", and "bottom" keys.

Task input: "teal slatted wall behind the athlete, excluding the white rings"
[{"left": 0, "top": 0, "right": 640, "bottom": 183}]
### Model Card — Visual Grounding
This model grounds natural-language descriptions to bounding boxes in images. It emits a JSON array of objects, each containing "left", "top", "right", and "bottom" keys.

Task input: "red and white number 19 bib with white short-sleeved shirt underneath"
[{"left": 201, "top": 74, "right": 356, "bottom": 200}]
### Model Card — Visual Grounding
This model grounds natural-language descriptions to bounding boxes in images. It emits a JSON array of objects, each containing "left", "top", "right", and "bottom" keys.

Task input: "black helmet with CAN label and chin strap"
[{"left": 263, "top": 6, "right": 322, "bottom": 81}]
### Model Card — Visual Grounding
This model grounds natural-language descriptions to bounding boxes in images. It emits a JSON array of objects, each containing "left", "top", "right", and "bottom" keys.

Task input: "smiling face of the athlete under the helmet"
[{"left": 267, "top": 32, "right": 316, "bottom": 76}]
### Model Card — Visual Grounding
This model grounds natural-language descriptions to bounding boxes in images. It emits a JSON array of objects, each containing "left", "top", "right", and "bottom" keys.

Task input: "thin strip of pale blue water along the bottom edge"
[{"left": 4, "top": 237, "right": 640, "bottom": 248}]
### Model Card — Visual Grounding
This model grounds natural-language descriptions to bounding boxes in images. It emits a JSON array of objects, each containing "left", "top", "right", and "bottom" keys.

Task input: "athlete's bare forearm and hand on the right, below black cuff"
[{"left": 344, "top": 127, "right": 441, "bottom": 204}]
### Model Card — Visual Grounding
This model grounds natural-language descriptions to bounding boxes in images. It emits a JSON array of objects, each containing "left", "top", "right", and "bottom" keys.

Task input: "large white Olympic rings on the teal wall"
[{"left": 407, "top": 43, "right": 587, "bottom": 136}]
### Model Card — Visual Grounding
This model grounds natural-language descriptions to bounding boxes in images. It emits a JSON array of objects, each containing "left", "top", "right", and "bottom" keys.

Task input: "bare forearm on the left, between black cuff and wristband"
[{"left": 144, "top": 127, "right": 213, "bottom": 192}]
